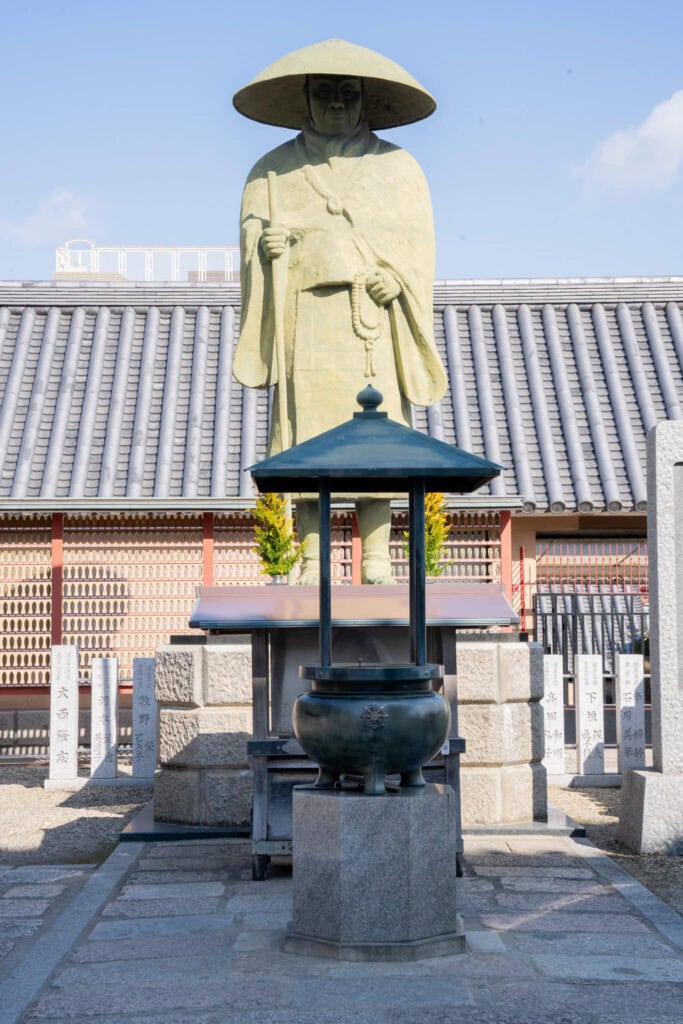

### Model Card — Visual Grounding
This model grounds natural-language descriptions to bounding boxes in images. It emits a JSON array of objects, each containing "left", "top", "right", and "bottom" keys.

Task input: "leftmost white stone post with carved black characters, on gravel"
[{"left": 45, "top": 644, "right": 79, "bottom": 790}]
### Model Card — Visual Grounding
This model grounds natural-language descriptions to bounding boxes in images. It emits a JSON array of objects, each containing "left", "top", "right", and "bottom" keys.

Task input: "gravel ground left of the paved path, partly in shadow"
[{"left": 0, "top": 764, "right": 153, "bottom": 864}]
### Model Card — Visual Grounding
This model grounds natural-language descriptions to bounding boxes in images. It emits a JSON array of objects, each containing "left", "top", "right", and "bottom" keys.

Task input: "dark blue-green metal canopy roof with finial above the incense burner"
[{"left": 250, "top": 385, "right": 503, "bottom": 494}]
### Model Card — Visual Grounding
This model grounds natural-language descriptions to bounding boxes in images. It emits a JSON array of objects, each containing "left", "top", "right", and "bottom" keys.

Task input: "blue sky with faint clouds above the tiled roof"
[{"left": 0, "top": 0, "right": 683, "bottom": 281}]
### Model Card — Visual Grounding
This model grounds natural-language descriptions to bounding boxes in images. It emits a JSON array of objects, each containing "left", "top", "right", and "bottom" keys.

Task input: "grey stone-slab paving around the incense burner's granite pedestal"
[{"left": 0, "top": 837, "right": 683, "bottom": 1024}]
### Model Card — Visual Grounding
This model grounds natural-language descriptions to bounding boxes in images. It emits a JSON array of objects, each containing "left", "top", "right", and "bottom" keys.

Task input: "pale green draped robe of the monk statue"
[{"left": 233, "top": 125, "right": 446, "bottom": 455}]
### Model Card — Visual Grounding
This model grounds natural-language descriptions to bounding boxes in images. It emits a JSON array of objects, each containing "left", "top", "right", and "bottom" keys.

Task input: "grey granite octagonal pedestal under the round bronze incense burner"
[{"left": 286, "top": 785, "right": 465, "bottom": 961}]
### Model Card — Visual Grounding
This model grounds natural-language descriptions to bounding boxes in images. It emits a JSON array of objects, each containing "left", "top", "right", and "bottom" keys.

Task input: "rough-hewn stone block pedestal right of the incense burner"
[{"left": 456, "top": 639, "right": 548, "bottom": 826}]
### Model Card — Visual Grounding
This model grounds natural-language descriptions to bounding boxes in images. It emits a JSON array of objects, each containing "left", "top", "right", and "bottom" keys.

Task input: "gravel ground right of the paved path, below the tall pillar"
[{"left": 548, "top": 786, "right": 683, "bottom": 914}]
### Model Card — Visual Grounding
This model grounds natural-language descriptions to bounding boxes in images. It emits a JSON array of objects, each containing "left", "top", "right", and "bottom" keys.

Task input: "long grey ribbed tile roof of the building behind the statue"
[{"left": 0, "top": 278, "right": 683, "bottom": 512}]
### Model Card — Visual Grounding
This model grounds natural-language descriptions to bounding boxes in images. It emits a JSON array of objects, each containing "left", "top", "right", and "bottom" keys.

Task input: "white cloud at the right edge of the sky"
[{"left": 581, "top": 89, "right": 683, "bottom": 191}]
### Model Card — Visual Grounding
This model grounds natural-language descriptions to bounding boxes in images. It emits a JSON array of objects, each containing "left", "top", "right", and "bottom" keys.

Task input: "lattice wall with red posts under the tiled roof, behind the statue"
[{"left": 0, "top": 510, "right": 501, "bottom": 688}]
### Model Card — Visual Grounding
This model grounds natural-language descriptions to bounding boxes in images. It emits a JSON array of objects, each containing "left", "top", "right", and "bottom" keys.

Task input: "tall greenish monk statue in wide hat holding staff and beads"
[{"left": 233, "top": 39, "right": 446, "bottom": 584}]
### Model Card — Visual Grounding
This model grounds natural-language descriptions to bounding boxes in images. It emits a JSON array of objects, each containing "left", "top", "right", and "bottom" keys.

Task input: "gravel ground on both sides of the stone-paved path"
[{"left": 0, "top": 764, "right": 683, "bottom": 914}]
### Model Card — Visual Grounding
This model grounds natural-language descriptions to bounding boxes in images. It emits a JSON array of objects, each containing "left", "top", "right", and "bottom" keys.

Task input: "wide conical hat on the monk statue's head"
[{"left": 232, "top": 39, "right": 436, "bottom": 129}]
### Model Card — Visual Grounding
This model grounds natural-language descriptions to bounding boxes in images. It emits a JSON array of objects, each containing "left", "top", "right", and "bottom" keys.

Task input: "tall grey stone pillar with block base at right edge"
[{"left": 618, "top": 421, "right": 683, "bottom": 853}]
